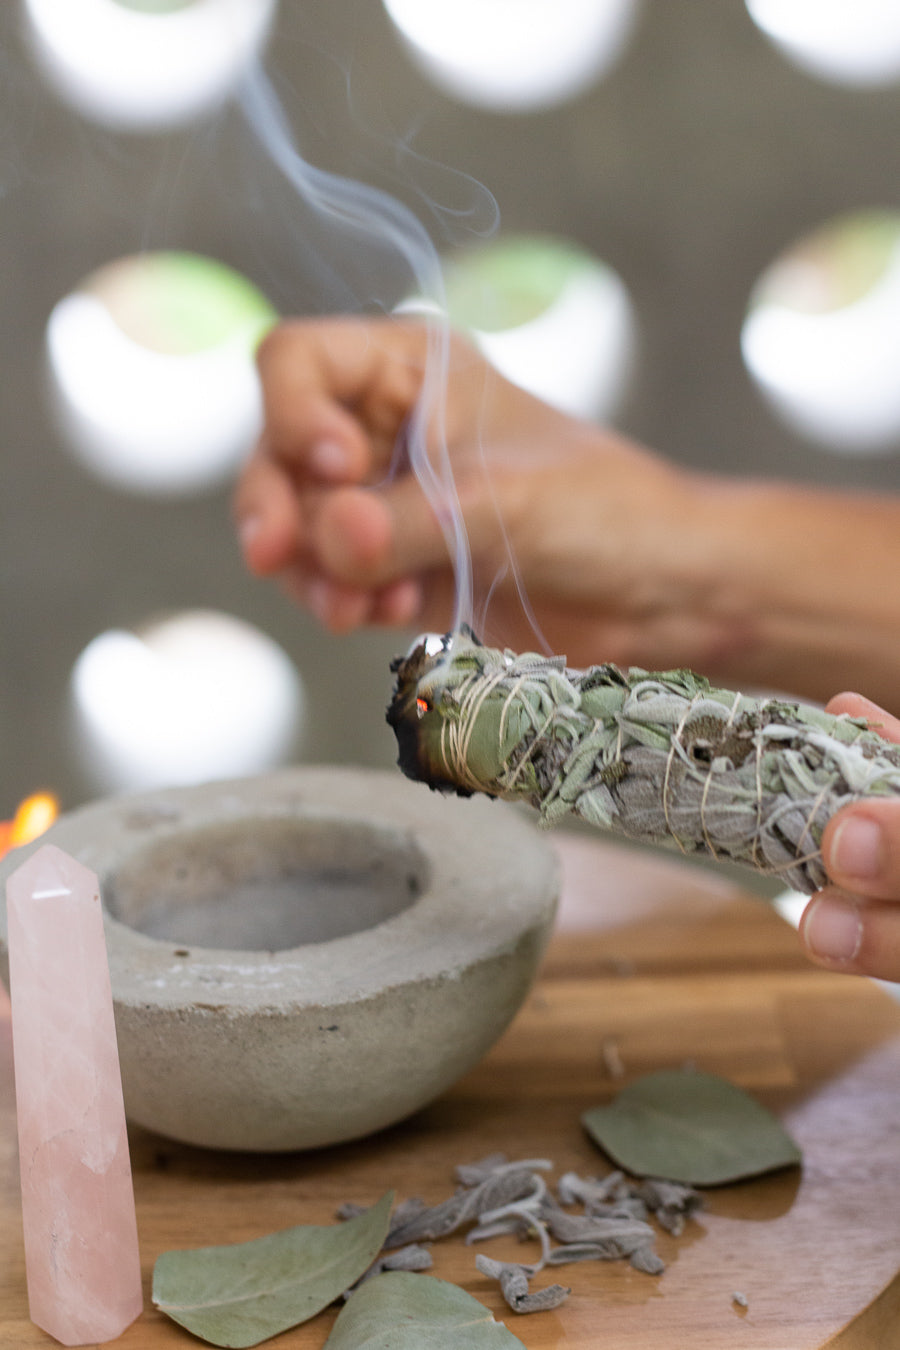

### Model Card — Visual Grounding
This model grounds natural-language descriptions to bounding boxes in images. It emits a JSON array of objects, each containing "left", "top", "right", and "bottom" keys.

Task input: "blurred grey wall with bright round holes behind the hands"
[{"left": 0, "top": 0, "right": 900, "bottom": 818}]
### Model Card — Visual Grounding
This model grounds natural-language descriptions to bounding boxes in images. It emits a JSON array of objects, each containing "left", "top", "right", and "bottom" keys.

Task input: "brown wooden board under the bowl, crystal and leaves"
[{"left": 0, "top": 834, "right": 900, "bottom": 1350}]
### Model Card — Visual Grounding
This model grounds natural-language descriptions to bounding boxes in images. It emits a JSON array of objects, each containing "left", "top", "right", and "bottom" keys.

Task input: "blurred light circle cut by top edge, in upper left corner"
[{"left": 24, "top": 0, "right": 275, "bottom": 131}]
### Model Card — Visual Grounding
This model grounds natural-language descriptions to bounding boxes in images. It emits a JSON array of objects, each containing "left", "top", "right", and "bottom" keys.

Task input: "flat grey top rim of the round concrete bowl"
[{"left": 0, "top": 767, "right": 555, "bottom": 1007}]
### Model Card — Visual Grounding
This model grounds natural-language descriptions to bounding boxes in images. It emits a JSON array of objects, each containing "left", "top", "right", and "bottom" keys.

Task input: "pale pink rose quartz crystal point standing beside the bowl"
[{"left": 7, "top": 844, "right": 143, "bottom": 1346}]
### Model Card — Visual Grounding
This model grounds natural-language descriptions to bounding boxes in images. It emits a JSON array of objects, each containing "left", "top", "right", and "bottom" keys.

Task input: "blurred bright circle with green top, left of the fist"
[{"left": 46, "top": 252, "right": 275, "bottom": 494}]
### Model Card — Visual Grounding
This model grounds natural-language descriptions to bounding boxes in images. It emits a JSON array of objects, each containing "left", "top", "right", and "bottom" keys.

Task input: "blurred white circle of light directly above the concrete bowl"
[{"left": 72, "top": 610, "right": 304, "bottom": 791}]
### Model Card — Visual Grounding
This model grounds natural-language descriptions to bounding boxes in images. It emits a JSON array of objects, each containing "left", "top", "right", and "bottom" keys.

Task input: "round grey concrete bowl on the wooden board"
[{"left": 0, "top": 767, "right": 559, "bottom": 1152}]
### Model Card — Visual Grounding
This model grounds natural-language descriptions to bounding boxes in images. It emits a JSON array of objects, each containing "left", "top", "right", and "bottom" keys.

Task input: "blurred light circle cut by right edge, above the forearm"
[{"left": 741, "top": 211, "right": 900, "bottom": 454}]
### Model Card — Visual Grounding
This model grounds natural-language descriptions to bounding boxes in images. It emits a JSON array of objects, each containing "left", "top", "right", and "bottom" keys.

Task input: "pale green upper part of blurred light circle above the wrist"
[{"left": 445, "top": 235, "right": 602, "bottom": 332}]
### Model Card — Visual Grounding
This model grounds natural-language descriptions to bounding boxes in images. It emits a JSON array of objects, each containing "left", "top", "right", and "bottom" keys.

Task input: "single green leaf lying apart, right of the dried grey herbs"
[{"left": 582, "top": 1069, "right": 800, "bottom": 1185}]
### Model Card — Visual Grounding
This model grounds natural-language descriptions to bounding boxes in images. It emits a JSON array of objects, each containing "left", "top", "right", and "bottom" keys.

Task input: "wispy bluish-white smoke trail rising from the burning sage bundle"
[{"left": 240, "top": 68, "right": 485, "bottom": 645}]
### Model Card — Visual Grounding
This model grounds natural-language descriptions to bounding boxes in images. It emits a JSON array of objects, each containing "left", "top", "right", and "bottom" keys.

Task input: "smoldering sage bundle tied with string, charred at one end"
[{"left": 387, "top": 633, "right": 900, "bottom": 894}]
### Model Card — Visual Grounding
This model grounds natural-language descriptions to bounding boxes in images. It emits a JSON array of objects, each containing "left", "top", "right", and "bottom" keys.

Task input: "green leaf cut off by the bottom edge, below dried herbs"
[{"left": 325, "top": 1270, "right": 525, "bottom": 1350}]
